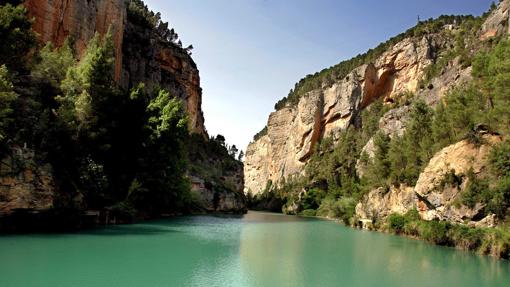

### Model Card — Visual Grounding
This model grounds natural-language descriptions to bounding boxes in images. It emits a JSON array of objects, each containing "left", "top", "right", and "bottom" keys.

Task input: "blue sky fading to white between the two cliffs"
[{"left": 145, "top": 0, "right": 492, "bottom": 150}]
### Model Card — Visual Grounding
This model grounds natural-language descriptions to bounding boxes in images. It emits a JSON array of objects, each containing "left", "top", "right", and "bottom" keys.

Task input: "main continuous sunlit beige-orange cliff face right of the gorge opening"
[{"left": 244, "top": 37, "right": 438, "bottom": 194}]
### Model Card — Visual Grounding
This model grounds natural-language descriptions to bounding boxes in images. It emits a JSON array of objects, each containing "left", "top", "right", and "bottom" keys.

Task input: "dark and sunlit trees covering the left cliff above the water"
[{"left": 0, "top": 1, "right": 240, "bottom": 227}]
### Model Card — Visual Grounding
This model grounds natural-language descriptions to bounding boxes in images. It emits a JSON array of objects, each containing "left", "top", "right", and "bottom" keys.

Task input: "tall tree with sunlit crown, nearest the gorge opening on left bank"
[{"left": 134, "top": 90, "right": 191, "bottom": 214}]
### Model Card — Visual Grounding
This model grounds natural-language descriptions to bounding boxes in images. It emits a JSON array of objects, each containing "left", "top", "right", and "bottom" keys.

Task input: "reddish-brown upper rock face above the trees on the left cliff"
[{"left": 24, "top": 0, "right": 207, "bottom": 136}]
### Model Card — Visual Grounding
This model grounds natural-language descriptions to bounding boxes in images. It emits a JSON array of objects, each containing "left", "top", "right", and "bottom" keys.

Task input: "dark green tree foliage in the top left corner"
[{"left": 0, "top": 3, "right": 35, "bottom": 71}]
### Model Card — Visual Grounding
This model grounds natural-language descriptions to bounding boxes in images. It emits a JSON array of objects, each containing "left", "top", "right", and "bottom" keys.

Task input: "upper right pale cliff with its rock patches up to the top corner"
[{"left": 244, "top": 1, "right": 510, "bottom": 197}]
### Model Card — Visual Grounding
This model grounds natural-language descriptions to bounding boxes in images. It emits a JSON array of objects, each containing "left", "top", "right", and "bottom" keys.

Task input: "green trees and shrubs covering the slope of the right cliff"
[{"left": 254, "top": 3, "right": 510, "bottom": 236}]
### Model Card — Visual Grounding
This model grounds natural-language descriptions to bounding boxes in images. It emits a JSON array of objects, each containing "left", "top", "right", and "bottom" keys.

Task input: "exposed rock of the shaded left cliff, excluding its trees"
[{"left": 0, "top": 0, "right": 246, "bottom": 218}]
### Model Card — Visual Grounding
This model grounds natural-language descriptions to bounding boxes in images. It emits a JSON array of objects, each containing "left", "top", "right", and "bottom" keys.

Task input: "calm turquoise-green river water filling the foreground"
[{"left": 0, "top": 212, "right": 510, "bottom": 287}]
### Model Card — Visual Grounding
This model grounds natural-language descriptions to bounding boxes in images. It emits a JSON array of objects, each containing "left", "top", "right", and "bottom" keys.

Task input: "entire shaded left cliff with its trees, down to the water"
[{"left": 0, "top": 0, "right": 246, "bottom": 231}]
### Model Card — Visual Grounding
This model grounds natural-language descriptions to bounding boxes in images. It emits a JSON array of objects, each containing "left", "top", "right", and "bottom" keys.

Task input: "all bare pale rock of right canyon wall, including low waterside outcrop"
[{"left": 244, "top": 0, "right": 510, "bottom": 232}]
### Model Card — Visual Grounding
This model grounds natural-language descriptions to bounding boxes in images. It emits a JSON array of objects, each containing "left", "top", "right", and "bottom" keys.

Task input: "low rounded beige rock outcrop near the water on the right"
[{"left": 356, "top": 135, "right": 501, "bottom": 226}]
